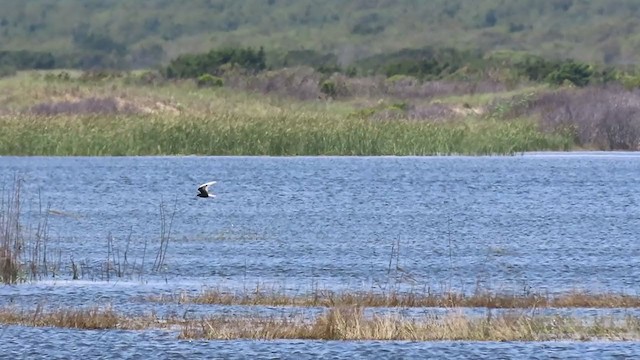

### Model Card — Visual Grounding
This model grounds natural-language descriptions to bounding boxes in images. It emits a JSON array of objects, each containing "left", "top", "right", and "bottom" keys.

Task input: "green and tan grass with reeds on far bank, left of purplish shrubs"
[{"left": 0, "top": 69, "right": 573, "bottom": 156}]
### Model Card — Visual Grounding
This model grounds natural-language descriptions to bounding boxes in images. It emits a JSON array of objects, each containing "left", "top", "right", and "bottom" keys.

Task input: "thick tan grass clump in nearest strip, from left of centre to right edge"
[{"left": 180, "top": 307, "right": 640, "bottom": 341}]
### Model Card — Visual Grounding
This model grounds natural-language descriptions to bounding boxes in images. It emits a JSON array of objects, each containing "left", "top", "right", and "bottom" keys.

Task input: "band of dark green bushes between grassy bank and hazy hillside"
[{"left": 0, "top": 47, "right": 630, "bottom": 86}]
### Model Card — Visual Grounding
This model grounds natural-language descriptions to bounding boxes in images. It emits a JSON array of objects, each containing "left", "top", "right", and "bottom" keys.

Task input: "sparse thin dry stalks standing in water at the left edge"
[{"left": 0, "top": 174, "right": 177, "bottom": 284}]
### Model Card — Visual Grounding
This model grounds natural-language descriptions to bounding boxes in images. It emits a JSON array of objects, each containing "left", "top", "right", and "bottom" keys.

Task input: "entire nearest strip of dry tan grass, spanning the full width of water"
[{"left": 0, "top": 306, "right": 640, "bottom": 341}]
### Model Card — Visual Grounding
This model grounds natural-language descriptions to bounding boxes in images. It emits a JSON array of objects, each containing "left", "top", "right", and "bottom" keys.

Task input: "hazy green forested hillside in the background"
[{"left": 0, "top": 0, "right": 640, "bottom": 68}]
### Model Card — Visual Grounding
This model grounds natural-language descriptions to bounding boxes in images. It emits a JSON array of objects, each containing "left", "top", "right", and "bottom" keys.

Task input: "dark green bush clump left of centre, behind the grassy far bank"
[{"left": 164, "top": 47, "right": 266, "bottom": 78}]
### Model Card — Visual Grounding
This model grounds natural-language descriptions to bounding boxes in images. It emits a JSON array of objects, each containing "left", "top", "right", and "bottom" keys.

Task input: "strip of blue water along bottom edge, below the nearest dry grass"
[{"left": 0, "top": 327, "right": 640, "bottom": 359}]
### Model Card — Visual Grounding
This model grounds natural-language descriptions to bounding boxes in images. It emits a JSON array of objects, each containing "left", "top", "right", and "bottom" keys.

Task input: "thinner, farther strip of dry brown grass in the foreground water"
[{"left": 145, "top": 288, "right": 640, "bottom": 309}]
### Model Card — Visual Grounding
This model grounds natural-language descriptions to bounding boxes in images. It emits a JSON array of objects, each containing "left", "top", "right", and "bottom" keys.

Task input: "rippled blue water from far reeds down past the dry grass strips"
[{"left": 0, "top": 153, "right": 640, "bottom": 358}]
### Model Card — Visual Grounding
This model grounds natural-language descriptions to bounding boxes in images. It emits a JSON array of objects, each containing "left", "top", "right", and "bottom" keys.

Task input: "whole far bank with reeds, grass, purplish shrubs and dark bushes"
[{"left": 0, "top": 44, "right": 640, "bottom": 156}]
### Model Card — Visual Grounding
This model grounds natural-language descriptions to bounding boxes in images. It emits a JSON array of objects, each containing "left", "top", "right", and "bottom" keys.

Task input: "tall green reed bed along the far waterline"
[{"left": 0, "top": 112, "right": 572, "bottom": 156}]
